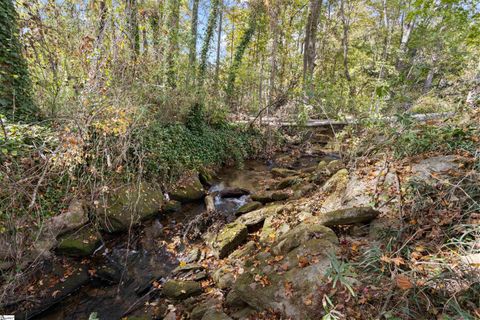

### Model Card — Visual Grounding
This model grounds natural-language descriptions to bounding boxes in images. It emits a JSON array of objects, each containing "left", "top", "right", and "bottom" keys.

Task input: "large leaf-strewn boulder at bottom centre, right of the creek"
[{"left": 229, "top": 223, "right": 338, "bottom": 319}]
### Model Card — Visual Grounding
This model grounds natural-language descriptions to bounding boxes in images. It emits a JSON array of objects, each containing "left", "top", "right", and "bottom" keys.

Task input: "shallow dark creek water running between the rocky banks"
[{"left": 29, "top": 132, "right": 335, "bottom": 320}]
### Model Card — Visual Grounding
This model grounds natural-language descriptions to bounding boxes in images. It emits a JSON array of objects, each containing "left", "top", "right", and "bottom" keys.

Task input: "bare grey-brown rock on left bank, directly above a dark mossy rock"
[{"left": 45, "top": 199, "right": 88, "bottom": 236}]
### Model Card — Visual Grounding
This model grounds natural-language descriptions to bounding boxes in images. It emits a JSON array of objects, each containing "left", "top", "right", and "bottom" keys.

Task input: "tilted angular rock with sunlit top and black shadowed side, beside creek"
[{"left": 212, "top": 222, "right": 248, "bottom": 259}]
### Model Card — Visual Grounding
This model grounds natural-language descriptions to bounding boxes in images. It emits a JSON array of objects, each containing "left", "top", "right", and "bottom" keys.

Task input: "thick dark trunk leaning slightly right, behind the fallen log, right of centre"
[{"left": 303, "top": 0, "right": 322, "bottom": 91}]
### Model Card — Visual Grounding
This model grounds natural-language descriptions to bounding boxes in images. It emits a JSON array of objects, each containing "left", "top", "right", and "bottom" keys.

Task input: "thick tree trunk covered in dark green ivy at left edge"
[{"left": 0, "top": 0, "right": 39, "bottom": 121}]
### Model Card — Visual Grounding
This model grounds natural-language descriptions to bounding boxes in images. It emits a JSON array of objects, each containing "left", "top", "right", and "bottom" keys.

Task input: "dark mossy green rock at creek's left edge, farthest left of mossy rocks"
[{"left": 57, "top": 227, "right": 101, "bottom": 257}]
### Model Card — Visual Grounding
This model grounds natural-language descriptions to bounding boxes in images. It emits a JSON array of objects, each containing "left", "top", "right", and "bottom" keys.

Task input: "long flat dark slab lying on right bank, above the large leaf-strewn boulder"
[{"left": 318, "top": 207, "right": 380, "bottom": 227}]
